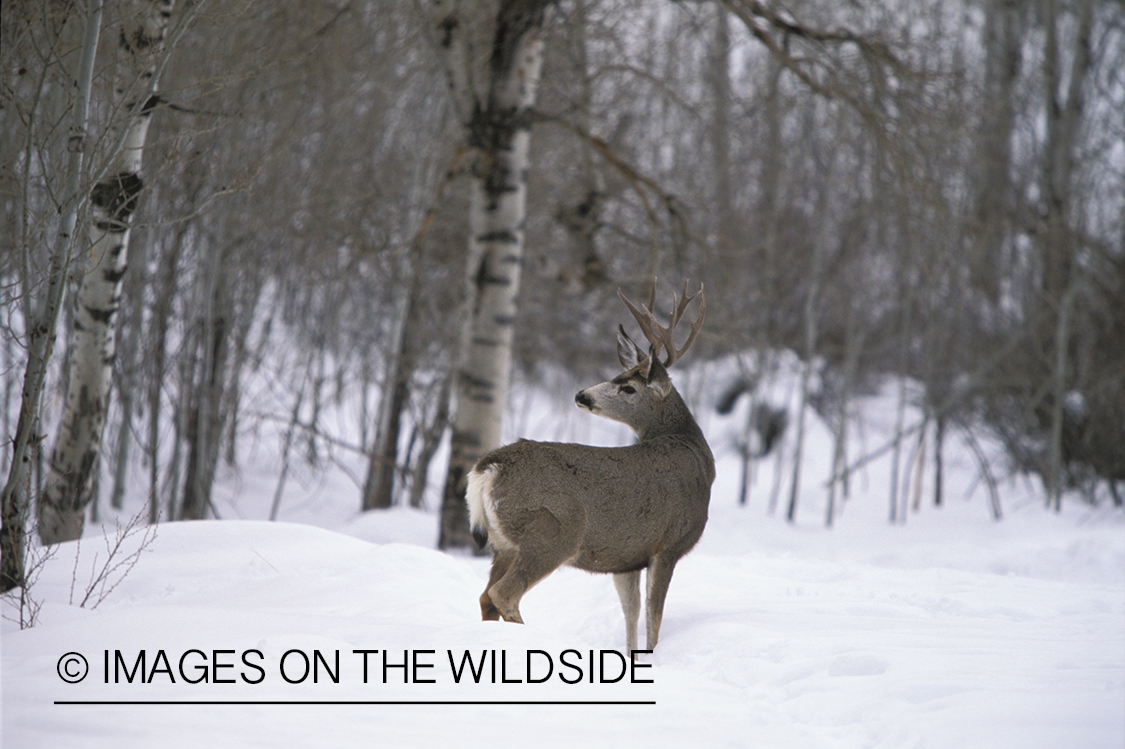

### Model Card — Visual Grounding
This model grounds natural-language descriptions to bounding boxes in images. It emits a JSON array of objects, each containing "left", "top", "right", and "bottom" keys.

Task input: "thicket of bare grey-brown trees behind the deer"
[{"left": 0, "top": 0, "right": 1125, "bottom": 587}]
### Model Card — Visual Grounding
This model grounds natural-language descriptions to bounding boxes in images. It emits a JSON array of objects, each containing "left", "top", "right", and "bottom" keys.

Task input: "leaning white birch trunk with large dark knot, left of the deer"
[{"left": 39, "top": 0, "right": 173, "bottom": 544}]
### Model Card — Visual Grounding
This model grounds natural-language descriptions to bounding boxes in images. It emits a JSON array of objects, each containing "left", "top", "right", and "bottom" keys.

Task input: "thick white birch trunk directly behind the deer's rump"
[{"left": 437, "top": 0, "right": 549, "bottom": 549}]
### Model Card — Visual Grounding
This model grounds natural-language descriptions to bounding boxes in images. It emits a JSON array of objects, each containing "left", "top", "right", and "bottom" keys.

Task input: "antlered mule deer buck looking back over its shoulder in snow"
[{"left": 467, "top": 282, "right": 714, "bottom": 656}]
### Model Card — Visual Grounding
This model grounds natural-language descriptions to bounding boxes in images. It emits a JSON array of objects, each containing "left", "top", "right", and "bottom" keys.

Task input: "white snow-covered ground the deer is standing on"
[{"left": 2, "top": 357, "right": 1125, "bottom": 749}]
